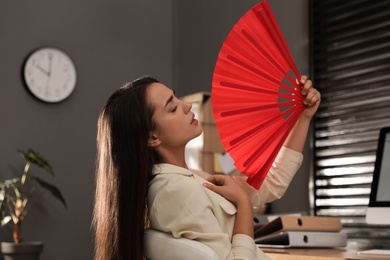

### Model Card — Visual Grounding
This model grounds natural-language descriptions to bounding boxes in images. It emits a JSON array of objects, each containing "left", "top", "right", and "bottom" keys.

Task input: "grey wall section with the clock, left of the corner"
[{"left": 0, "top": 0, "right": 173, "bottom": 260}]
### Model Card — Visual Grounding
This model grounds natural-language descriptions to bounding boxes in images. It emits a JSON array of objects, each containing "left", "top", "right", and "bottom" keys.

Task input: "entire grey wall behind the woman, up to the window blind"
[{"left": 0, "top": 0, "right": 309, "bottom": 260}]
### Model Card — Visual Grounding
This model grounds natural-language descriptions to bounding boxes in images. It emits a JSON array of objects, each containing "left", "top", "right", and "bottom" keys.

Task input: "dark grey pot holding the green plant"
[{"left": 1, "top": 242, "right": 43, "bottom": 260}]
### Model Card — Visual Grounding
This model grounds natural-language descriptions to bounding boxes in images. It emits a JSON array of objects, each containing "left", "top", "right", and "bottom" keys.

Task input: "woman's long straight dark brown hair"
[{"left": 92, "top": 76, "right": 158, "bottom": 260}]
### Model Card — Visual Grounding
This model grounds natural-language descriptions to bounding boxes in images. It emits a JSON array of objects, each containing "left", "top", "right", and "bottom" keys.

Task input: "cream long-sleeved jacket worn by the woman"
[{"left": 148, "top": 147, "right": 302, "bottom": 259}]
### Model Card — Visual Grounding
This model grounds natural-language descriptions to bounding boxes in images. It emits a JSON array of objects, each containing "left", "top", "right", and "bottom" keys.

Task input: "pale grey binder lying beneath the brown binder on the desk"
[{"left": 255, "top": 231, "right": 347, "bottom": 248}]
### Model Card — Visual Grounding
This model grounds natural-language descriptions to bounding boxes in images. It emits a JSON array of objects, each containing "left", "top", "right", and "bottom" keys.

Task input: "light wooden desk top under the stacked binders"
[{"left": 261, "top": 248, "right": 385, "bottom": 260}]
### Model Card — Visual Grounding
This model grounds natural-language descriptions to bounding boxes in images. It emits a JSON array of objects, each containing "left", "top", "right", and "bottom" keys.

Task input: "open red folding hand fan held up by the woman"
[{"left": 212, "top": 0, "right": 304, "bottom": 189}]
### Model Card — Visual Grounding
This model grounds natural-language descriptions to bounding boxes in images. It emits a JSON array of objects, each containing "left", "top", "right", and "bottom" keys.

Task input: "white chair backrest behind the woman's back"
[{"left": 144, "top": 228, "right": 219, "bottom": 260}]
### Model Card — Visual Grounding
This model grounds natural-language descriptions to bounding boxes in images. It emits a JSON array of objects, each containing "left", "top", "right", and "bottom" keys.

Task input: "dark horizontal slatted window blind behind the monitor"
[{"left": 310, "top": 0, "right": 390, "bottom": 249}]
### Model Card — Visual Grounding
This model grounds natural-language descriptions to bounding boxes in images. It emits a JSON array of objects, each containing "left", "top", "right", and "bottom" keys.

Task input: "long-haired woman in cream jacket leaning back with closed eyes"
[{"left": 93, "top": 74, "right": 320, "bottom": 260}]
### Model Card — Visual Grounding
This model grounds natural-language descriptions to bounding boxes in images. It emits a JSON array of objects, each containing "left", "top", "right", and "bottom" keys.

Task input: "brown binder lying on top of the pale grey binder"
[{"left": 254, "top": 216, "right": 342, "bottom": 238}]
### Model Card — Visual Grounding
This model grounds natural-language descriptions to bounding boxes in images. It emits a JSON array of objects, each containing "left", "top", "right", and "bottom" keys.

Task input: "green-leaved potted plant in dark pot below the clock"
[{"left": 0, "top": 149, "right": 67, "bottom": 260}]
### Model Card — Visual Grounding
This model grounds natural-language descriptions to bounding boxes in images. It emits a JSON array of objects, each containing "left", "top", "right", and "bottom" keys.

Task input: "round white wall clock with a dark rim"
[{"left": 23, "top": 47, "right": 77, "bottom": 103}]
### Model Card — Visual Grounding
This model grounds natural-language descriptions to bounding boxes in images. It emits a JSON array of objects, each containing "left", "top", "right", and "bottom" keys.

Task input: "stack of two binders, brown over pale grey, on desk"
[{"left": 255, "top": 216, "right": 347, "bottom": 248}]
